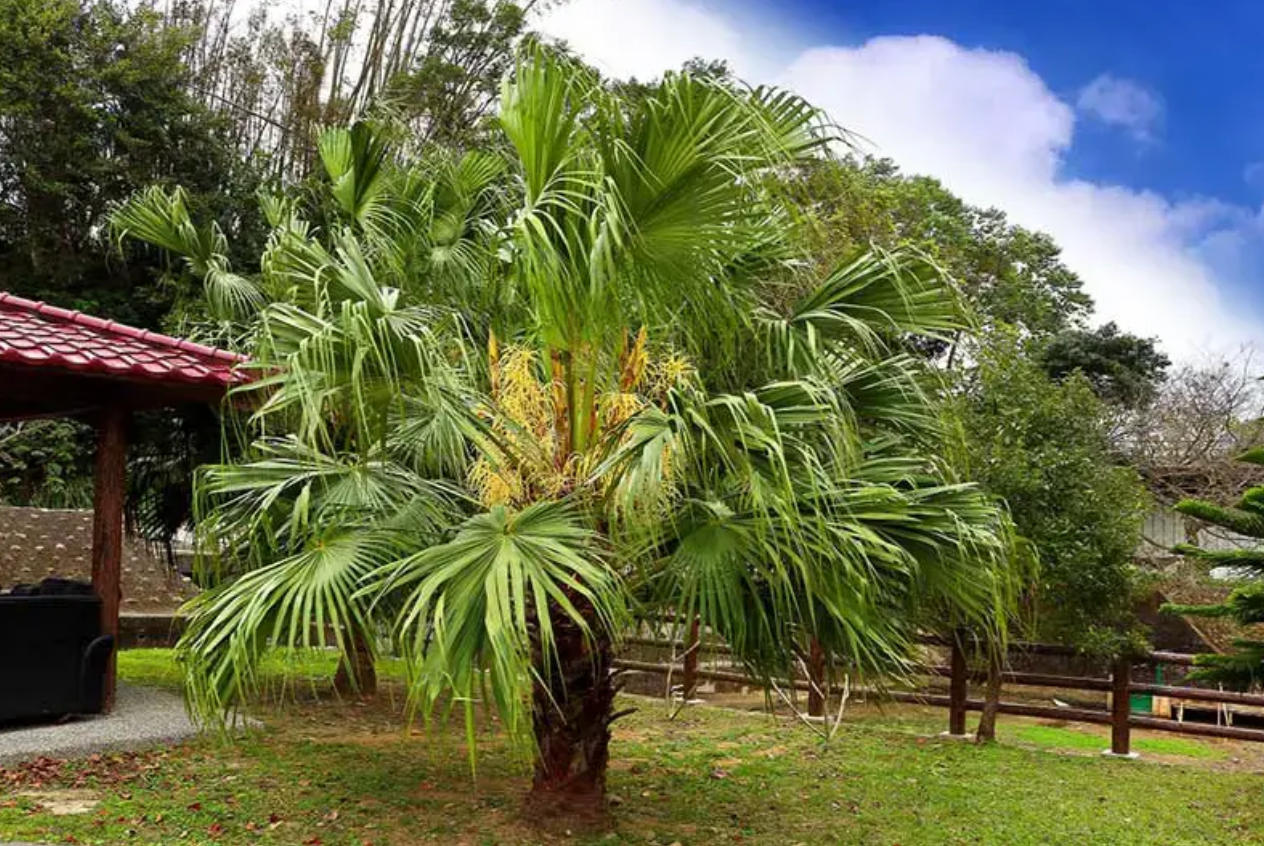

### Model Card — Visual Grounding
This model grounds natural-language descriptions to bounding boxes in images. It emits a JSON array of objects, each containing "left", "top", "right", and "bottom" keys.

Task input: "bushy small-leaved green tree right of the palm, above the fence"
[{"left": 956, "top": 334, "right": 1149, "bottom": 653}]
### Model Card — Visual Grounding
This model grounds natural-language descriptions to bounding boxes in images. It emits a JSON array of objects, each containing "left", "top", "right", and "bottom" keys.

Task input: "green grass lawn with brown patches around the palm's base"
[{"left": 0, "top": 651, "right": 1264, "bottom": 846}]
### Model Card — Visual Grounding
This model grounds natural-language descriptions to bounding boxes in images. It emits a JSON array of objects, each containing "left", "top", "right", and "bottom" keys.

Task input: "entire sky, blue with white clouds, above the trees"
[{"left": 540, "top": 0, "right": 1264, "bottom": 360}]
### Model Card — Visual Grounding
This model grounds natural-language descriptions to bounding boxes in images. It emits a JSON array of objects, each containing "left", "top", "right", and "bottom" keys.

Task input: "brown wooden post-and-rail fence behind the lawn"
[{"left": 616, "top": 625, "right": 1264, "bottom": 756}]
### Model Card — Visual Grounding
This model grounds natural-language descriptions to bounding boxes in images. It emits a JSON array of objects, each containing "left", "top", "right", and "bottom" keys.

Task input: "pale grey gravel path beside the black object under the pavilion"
[{"left": 0, "top": 684, "right": 197, "bottom": 768}]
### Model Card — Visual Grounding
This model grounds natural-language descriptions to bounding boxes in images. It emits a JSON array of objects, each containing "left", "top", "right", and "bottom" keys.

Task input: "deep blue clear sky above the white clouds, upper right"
[{"left": 781, "top": 0, "right": 1264, "bottom": 204}]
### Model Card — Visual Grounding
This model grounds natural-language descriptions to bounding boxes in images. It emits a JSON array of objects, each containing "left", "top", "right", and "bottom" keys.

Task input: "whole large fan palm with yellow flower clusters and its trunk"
[{"left": 113, "top": 48, "right": 1009, "bottom": 804}]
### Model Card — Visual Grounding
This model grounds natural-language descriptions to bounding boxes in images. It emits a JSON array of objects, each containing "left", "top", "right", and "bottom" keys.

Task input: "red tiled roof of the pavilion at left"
[{"left": 0, "top": 292, "right": 245, "bottom": 387}]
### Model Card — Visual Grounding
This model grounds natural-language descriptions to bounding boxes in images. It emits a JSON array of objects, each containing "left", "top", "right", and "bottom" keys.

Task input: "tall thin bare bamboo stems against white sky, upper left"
[{"left": 167, "top": 0, "right": 536, "bottom": 182}]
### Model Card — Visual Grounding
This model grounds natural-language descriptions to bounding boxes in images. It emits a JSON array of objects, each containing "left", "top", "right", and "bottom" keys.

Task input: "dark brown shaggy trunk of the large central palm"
[{"left": 528, "top": 602, "right": 616, "bottom": 818}]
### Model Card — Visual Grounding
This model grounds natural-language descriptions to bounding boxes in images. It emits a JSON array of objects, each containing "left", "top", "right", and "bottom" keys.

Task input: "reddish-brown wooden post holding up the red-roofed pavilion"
[{"left": 92, "top": 406, "right": 128, "bottom": 713}]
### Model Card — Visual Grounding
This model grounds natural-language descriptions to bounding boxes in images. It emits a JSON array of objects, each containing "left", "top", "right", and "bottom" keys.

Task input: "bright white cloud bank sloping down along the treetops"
[{"left": 542, "top": 0, "right": 1264, "bottom": 358}]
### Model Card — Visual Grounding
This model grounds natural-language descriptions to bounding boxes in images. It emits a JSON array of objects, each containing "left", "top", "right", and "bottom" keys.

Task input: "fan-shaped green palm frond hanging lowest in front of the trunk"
[{"left": 362, "top": 502, "right": 627, "bottom": 758}]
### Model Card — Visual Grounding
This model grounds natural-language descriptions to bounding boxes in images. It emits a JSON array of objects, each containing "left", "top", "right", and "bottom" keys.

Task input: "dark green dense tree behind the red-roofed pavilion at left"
[{"left": 0, "top": 0, "right": 260, "bottom": 507}]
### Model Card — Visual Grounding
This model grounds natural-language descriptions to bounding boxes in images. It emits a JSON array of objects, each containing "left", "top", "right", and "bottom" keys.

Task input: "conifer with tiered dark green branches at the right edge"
[{"left": 1164, "top": 449, "right": 1264, "bottom": 689}]
